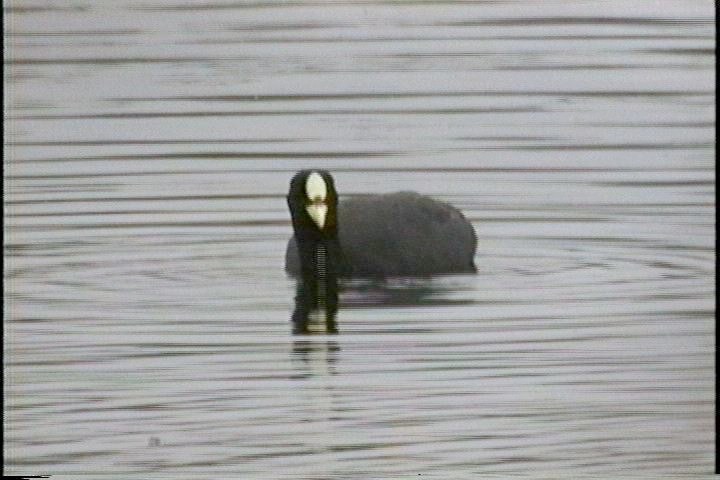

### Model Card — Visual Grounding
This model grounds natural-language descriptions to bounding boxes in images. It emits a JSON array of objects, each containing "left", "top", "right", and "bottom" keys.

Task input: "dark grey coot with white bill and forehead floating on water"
[{"left": 285, "top": 170, "right": 477, "bottom": 282}]
